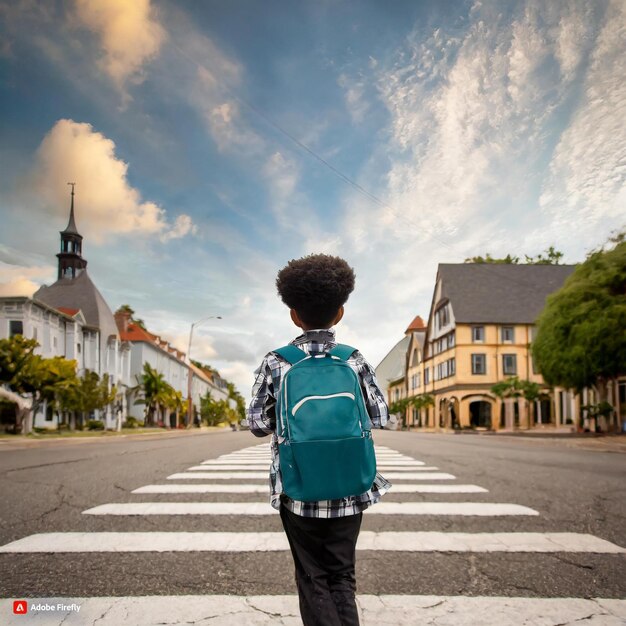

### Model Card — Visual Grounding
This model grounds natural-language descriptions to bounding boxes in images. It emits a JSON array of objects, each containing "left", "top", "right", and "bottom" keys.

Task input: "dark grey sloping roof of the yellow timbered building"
[{"left": 435, "top": 263, "right": 576, "bottom": 324}]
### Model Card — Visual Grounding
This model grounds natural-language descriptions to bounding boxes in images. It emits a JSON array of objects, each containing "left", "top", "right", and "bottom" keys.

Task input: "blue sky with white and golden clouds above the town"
[{"left": 0, "top": 0, "right": 626, "bottom": 397}]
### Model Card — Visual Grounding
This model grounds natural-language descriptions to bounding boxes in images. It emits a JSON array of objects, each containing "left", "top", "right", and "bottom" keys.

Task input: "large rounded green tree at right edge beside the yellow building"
[{"left": 532, "top": 235, "right": 626, "bottom": 426}]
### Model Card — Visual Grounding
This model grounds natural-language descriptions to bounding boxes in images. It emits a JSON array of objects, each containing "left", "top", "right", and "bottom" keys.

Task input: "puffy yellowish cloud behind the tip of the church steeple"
[{"left": 31, "top": 119, "right": 195, "bottom": 242}]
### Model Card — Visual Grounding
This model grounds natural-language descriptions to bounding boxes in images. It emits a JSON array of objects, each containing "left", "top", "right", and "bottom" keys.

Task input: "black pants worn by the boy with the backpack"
[{"left": 280, "top": 506, "right": 363, "bottom": 626}]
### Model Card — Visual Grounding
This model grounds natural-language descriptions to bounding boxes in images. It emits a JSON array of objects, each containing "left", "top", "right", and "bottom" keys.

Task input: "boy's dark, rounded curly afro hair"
[{"left": 276, "top": 254, "right": 355, "bottom": 328}]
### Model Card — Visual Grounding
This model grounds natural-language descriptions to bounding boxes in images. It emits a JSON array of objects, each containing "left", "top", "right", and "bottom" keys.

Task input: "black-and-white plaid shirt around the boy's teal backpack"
[{"left": 248, "top": 329, "right": 391, "bottom": 517}]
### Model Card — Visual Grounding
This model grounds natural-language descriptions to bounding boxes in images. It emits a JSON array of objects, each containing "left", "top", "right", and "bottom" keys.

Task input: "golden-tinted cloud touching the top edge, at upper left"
[{"left": 75, "top": 0, "right": 166, "bottom": 96}]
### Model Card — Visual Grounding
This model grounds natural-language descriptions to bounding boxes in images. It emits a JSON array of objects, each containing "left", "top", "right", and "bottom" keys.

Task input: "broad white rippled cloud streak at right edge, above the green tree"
[{"left": 540, "top": 2, "right": 626, "bottom": 239}]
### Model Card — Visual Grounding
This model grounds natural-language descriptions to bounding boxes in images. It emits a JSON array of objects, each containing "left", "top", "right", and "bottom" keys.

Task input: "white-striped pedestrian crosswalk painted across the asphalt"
[{"left": 0, "top": 444, "right": 626, "bottom": 626}]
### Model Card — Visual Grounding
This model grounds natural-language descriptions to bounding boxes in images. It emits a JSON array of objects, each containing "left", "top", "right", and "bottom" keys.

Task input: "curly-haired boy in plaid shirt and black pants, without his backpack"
[{"left": 248, "top": 254, "right": 391, "bottom": 626}]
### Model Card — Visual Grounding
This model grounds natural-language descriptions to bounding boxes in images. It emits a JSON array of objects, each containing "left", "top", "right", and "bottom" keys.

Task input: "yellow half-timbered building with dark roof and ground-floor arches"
[{"left": 400, "top": 263, "right": 585, "bottom": 430}]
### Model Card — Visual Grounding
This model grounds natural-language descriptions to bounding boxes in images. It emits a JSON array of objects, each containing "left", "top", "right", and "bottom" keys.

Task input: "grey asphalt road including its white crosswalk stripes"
[{"left": 0, "top": 431, "right": 626, "bottom": 626}]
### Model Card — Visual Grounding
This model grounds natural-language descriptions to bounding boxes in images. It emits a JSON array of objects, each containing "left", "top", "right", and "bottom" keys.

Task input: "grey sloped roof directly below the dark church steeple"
[{"left": 33, "top": 270, "right": 118, "bottom": 341}]
